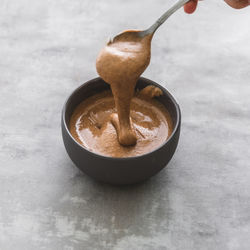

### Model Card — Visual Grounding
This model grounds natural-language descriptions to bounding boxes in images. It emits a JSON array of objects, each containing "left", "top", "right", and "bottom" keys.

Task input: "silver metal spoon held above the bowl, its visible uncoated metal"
[{"left": 109, "top": 0, "right": 190, "bottom": 43}]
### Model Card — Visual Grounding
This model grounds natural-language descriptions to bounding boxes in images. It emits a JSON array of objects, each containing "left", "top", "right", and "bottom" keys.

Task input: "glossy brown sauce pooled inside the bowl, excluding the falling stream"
[{"left": 70, "top": 89, "right": 172, "bottom": 157}]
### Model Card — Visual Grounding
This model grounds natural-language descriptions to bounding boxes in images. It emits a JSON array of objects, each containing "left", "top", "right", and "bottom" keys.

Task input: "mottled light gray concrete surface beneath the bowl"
[{"left": 0, "top": 0, "right": 250, "bottom": 250}]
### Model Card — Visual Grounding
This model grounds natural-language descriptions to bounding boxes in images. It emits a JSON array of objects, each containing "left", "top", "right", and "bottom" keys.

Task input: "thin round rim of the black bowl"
[{"left": 61, "top": 77, "right": 181, "bottom": 161}]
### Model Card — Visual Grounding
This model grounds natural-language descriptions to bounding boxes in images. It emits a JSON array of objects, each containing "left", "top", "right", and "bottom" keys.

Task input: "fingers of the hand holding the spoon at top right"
[{"left": 184, "top": 0, "right": 250, "bottom": 14}]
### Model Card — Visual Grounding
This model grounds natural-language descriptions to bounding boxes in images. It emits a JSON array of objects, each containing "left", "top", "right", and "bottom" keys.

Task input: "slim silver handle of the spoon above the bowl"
[{"left": 141, "top": 0, "right": 190, "bottom": 36}]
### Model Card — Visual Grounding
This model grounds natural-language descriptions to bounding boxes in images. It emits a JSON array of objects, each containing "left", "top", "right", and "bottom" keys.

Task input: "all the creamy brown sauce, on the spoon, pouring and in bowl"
[{"left": 70, "top": 31, "right": 172, "bottom": 157}]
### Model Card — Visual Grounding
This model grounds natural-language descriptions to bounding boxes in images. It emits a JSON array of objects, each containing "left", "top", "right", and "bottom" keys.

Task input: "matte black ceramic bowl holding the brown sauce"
[{"left": 61, "top": 77, "right": 181, "bottom": 185}]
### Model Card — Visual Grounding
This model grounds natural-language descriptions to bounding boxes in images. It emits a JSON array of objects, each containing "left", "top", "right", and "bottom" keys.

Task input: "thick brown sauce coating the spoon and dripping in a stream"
[{"left": 96, "top": 30, "right": 152, "bottom": 146}]
